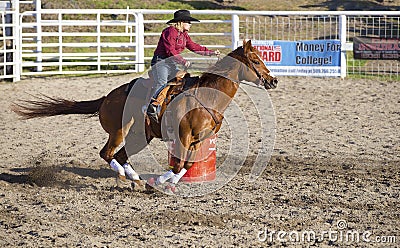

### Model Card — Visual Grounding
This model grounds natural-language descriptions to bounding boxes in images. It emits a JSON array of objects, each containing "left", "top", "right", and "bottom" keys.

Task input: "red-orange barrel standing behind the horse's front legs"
[{"left": 168, "top": 134, "right": 217, "bottom": 183}]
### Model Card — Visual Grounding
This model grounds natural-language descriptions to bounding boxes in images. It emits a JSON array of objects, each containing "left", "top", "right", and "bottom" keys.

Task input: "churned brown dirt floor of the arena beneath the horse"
[{"left": 0, "top": 75, "right": 400, "bottom": 247}]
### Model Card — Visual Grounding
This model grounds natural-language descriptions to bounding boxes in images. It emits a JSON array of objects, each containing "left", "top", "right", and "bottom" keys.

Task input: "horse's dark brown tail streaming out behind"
[{"left": 12, "top": 96, "right": 106, "bottom": 119}]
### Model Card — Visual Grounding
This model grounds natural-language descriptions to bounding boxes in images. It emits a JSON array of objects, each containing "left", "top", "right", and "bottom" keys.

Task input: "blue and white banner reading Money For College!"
[{"left": 252, "top": 40, "right": 341, "bottom": 77}]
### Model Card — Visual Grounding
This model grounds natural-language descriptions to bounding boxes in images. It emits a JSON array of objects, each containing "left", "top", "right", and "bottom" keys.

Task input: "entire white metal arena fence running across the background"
[{"left": 0, "top": 0, "right": 400, "bottom": 81}]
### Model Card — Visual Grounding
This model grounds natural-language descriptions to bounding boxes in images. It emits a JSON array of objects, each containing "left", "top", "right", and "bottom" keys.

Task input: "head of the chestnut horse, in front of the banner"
[{"left": 240, "top": 40, "right": 278, "bottom": 90}]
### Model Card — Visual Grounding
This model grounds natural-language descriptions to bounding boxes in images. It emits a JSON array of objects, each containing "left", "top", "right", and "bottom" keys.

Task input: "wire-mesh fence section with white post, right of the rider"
[{"left": 241, "top": 11, "right": 400, "bottom": 79}]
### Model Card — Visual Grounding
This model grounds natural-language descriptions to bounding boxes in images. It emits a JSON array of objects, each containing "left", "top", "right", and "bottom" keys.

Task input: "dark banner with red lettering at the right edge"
[{"left": 353, "top": 36, "right": 400, "bottom": 60}]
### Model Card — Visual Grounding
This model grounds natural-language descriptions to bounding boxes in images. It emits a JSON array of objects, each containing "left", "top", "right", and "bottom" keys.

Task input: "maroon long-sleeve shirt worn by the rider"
[{"left": 154, "top": 26, "right": 214, "bottom": 65}]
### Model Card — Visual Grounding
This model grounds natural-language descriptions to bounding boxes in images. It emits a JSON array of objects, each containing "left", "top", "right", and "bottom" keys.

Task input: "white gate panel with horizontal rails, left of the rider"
[{"left": 20, "top": 9, "right": 143, "bottom": 75}]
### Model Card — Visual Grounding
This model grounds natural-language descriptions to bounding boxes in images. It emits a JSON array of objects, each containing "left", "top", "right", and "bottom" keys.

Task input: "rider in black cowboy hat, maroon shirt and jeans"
[{"left": 147, "top": 10, "right": 220, "bottom": 122}]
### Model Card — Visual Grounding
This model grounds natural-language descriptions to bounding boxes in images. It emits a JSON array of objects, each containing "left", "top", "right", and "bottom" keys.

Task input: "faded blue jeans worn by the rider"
[{"left": 151, "top": 55, "right": 179, "bottom": 95}]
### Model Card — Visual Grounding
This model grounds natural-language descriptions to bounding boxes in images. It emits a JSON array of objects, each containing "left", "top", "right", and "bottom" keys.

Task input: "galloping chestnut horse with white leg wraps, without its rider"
[{"left": 14, "top": 41, "right": 278, "bottom": 190}]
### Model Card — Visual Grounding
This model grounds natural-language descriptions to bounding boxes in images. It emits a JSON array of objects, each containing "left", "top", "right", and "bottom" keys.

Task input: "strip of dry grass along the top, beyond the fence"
[{"left": 42, "top": 0, "right": 400, "bottom": 10}]
